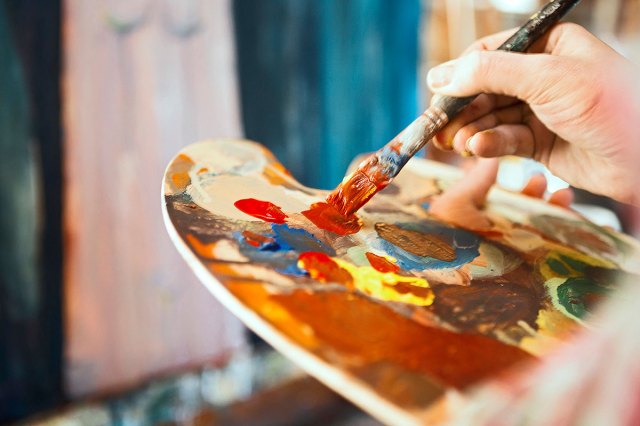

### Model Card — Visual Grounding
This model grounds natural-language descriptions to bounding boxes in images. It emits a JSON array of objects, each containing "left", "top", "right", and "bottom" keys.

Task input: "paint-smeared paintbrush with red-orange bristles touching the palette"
[{"left": 327, "top": 0, "right": 580, "bottom": 216}]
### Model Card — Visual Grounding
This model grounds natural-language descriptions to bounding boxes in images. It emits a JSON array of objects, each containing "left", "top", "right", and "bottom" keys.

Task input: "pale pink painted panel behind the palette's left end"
[{"left": 63, "top": 0, "right": 243, "bottom": 396}]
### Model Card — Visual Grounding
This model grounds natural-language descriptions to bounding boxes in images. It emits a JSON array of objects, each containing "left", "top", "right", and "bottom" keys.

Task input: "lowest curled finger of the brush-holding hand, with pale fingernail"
[{"left": 467, "top": 124, "right": 535, "bottom": 158}]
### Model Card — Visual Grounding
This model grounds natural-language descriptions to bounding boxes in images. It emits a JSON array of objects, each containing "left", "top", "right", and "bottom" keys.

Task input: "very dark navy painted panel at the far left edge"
[{"left": 0, "top": 0, "right": 63, "bottom": 423}]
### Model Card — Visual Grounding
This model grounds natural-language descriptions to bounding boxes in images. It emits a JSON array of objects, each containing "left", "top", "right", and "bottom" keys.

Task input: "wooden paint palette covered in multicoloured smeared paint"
[{"left": 163, "top": 140, "right": 639, "bottom": 424}]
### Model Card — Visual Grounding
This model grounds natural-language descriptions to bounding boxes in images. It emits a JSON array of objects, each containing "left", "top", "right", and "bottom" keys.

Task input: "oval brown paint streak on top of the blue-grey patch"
[{"left": 375, "top": 223, "right": 457, "bottom": 262}]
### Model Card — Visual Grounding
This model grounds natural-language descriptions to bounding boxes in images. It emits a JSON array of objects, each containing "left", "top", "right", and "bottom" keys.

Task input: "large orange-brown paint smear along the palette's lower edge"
[{"left": 227, "top": 283, "right": 534, "bottom": 389}]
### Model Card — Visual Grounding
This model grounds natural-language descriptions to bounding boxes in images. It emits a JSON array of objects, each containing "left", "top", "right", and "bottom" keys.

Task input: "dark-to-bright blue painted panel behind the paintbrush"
[{"left": 234, "top": 0, "right": 421, "bottom": 189}]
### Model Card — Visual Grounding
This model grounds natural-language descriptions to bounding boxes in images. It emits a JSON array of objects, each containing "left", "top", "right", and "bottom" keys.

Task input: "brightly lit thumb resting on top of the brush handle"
[{"left": 427, "top": 50, "right": 564, "bottom": 104}]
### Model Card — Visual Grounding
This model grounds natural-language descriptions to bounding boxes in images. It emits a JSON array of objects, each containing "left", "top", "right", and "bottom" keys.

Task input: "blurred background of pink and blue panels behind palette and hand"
[{"left": 0, "top": 0, "right": 640, "bottom": 425}]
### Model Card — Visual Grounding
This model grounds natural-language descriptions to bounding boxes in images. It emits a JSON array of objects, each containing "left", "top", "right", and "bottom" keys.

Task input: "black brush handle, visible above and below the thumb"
[{"left": 434, "top": 0, "right": 580, "bottom": 121}]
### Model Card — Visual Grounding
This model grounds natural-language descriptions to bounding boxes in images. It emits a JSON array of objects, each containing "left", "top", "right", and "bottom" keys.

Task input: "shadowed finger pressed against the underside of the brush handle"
[{"left": 434, "top": 94, "right": 518, "bottom": 151}]
